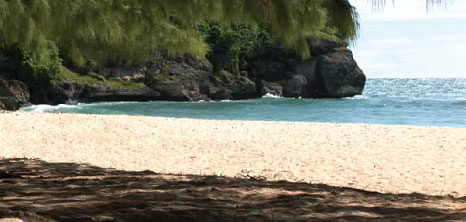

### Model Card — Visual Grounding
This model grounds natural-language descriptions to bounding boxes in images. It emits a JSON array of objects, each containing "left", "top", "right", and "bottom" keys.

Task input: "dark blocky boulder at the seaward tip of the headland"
[{"left": 317, "top": 49, "right": 366, "bottom": 98}]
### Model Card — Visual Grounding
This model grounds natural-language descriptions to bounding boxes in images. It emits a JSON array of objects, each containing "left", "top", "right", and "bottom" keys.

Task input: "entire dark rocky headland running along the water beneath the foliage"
[{"left": 0, "top": 40, "right": 366, "bottom": 111}]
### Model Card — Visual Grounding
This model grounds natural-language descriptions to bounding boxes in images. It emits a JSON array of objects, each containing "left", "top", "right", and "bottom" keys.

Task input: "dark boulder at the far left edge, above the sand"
[{"left": 0, "top": 79, "right": 30, "bottom": 111}]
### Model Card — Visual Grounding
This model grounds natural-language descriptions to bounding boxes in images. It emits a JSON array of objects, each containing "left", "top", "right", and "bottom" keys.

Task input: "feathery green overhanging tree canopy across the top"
[{"left": 0, "top": 0, "right": 358, "bottom": 65}]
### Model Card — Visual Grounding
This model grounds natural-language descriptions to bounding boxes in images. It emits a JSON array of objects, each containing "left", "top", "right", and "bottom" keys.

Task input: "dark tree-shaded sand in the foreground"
[{"left": 0, "top": 159, "right": 466, "bottom": 222}]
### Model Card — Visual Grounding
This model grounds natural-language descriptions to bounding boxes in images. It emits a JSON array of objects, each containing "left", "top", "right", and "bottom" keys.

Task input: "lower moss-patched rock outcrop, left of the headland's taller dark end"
[{"left": 52, "top": 55, "right": 257, "bottom": 103}]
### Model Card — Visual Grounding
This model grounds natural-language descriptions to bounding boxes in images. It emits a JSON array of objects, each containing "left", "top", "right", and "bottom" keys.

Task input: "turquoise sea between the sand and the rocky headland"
[{"left": 22, "top": 79, "right": 466, "bottom": 128}]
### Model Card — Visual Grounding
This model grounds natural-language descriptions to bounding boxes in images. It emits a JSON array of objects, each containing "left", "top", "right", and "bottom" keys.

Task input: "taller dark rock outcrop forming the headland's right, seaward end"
[{"left": 247, "top": 37, "right": 366, "bottom": 98}]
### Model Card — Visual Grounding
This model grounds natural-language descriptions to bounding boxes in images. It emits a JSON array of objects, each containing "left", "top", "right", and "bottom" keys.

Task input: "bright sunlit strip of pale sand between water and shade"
[{"left": 0, "top": 113, "right": 466, "bottom": 196}]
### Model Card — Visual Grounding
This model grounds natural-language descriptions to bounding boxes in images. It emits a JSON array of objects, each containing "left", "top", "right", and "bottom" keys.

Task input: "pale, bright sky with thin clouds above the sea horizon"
[{"left": 350, "top": 0, "right": 466, "bottom": 78}]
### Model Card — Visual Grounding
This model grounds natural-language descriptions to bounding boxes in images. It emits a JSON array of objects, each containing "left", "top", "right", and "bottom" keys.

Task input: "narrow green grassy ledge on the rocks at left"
[{"left": 51, "top": 67, "right": 146, "bottom": 90}]
